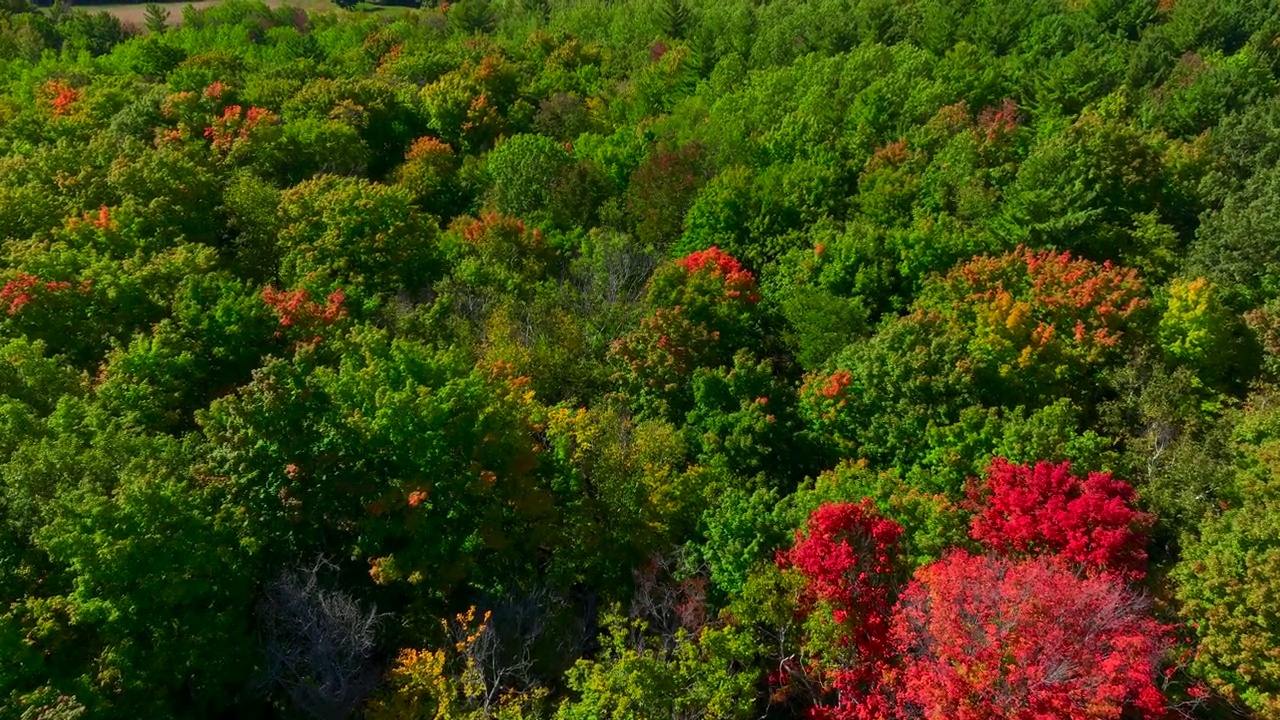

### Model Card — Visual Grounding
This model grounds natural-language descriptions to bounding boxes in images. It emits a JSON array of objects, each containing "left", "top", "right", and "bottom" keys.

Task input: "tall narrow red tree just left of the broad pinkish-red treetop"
[{"left": 778, "top": 500, "right": 902, "bottom": 720}]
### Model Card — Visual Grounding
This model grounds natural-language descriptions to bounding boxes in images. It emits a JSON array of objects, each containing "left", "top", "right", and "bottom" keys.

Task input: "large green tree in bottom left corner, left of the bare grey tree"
[{"left": 0, "top": 417, "right": 257, "bottom": 719}]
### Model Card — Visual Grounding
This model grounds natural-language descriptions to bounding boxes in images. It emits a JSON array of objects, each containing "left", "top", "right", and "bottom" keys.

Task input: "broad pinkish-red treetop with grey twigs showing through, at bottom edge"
[{"left": 892, "top": 551, "right": 1169, "bottom": 720}]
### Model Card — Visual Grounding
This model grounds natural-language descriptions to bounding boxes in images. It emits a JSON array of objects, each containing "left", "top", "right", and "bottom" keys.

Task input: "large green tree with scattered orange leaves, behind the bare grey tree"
[{"left": 200, "top": 327, "right": 550, "bottom": 603}]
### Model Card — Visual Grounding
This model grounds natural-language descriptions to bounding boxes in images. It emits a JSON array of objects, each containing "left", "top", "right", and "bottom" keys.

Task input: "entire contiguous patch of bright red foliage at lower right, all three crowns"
[{"left": 777, "top": 491, "right": 1169, "bottom": 720}]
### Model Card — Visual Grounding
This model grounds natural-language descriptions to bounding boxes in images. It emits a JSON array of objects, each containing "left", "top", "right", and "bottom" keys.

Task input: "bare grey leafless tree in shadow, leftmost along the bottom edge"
[{"left": 259, "top": 556, "right": 387, "bottom": 720}]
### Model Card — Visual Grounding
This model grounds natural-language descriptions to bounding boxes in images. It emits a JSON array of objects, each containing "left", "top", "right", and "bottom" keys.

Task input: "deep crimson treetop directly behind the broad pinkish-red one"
[{"left": 969, "top": 457, "right": 1155, "bottom": 580}]
